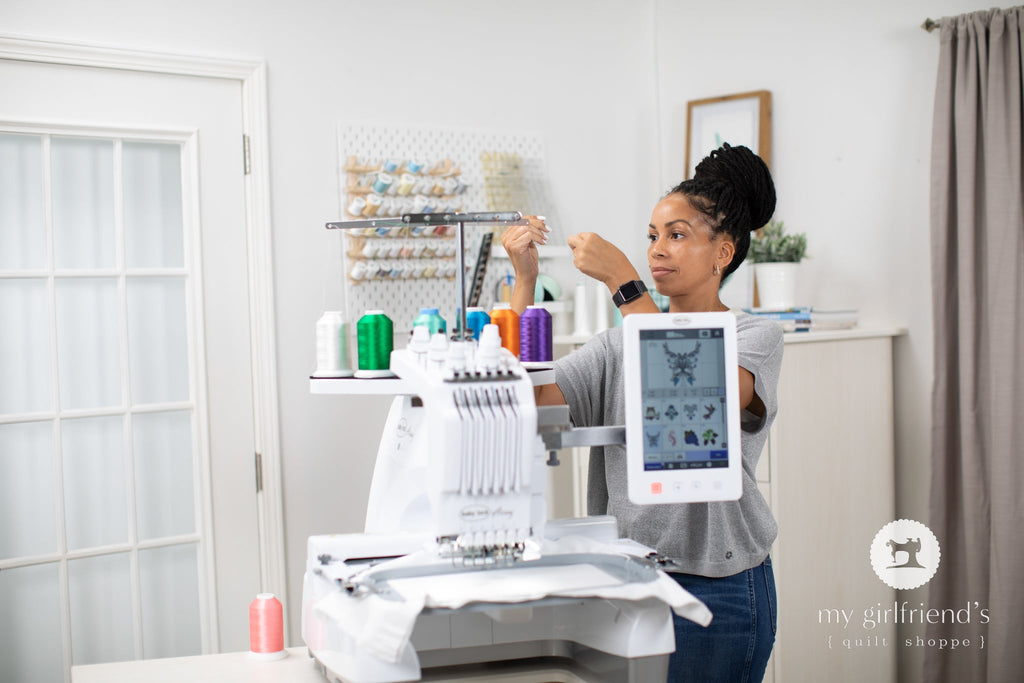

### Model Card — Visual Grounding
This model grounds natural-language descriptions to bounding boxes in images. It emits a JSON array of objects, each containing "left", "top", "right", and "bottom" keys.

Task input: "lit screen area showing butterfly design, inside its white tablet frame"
[{"left": 640, "top": 328, "right": 729, "bottom": 471}]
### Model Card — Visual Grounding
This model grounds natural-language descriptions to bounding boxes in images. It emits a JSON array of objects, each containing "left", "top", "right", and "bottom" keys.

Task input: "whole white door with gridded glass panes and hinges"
[{"left": 0, "top": 52, "right": 268, "bottom": 681}]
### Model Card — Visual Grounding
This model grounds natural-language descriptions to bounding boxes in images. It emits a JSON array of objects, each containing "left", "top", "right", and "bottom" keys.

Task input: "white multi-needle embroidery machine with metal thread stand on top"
[{"left": 302, "top": 213, "right": 724, "bottom": 683}]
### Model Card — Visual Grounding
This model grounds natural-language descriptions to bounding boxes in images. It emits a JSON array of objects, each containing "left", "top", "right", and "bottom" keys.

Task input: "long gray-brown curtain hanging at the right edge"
[{"left": 929, "top": 7, "right": 1024, "bottom": 683}]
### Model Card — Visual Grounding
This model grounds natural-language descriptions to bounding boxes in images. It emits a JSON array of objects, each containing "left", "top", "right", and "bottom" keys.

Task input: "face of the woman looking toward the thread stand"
[{"left": 647, "top": 193, "right": 735, "bottom": 297}]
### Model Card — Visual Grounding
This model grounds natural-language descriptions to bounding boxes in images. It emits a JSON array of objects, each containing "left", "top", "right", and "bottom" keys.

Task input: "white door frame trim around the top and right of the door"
[{"left": 0, "top": 34, "right": 287, "bottom": 626}]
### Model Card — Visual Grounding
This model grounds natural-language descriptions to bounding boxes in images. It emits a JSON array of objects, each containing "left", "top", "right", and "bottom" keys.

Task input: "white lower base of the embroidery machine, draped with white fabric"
[{"left": 303, "top": 532, "right": 711, "bottom": 683}]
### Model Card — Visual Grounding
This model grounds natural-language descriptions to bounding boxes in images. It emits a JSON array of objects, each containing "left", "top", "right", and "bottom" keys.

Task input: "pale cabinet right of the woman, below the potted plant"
[{"left": 758, "top": 330, "right": 897, "bottom": 683}]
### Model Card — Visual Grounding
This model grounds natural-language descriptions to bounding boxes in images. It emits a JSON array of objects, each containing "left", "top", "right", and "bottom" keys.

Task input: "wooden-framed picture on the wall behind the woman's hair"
[{"left": 686, "top": 90, "right": 771, "bottom": 178}]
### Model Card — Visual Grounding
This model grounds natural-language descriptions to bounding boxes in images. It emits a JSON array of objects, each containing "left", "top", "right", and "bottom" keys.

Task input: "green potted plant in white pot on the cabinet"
[{"left": 750, "top": 218, "right": 807, "bottom": 310}]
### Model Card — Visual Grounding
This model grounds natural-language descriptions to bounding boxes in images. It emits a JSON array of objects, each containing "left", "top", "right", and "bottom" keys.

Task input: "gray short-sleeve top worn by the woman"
[{"left": 555, "top": 313, "right": 783, "bottom": 577}]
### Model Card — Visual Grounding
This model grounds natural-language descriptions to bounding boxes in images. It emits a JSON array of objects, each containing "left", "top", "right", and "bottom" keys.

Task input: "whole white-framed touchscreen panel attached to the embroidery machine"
[{"left": 623, "top": 312, "right": 743, "bottom": 505}]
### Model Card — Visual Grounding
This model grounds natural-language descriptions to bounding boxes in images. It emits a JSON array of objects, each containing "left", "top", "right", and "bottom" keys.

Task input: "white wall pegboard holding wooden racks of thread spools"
[{"left": 338, "top": 122, "right": 560, "bottom": 336}]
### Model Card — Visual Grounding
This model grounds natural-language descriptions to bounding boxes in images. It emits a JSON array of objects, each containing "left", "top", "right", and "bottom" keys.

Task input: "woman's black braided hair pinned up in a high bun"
[{"left": 669, "top": 143, "right": 775, "bottom": 282}]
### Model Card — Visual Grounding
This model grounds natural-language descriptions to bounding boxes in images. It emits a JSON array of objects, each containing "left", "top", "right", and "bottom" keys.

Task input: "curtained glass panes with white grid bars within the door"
[{"left": 0, "top": 130, "right": 210, "bottom": 681}]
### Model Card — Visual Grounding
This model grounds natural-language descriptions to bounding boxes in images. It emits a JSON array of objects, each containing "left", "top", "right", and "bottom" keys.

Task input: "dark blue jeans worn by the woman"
[{"left": 669, "top": 558, "right": 777, "bottom": 683}]
